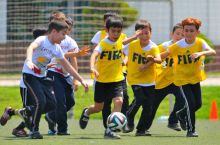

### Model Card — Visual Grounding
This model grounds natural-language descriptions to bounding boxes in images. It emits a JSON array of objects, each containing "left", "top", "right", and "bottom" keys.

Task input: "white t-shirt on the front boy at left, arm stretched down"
[{"left": 22, "top": 36, "right": 64, "bottom": 77}]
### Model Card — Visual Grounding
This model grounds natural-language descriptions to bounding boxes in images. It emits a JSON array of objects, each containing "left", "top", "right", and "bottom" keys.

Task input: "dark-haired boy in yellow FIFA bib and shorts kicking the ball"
[{"left": 79, "top": 17, "right": 124, "bottom": 139}]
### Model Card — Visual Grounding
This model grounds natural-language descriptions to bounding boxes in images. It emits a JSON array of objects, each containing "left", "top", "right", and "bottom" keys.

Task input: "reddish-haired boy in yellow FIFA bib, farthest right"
[{"left": 161, "top": 17, "right": 216, "bottom": 137}]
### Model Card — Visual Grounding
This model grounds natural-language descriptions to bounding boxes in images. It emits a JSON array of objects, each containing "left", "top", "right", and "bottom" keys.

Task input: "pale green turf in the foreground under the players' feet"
[{"left": 0, "top": 118, "right": 220, "bottom": 145}]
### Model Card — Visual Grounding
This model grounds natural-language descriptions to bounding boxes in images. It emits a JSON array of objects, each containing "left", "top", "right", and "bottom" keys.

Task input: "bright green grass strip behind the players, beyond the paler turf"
[{"left": 0, "top": 86, "right": 220, "bottom": 119}]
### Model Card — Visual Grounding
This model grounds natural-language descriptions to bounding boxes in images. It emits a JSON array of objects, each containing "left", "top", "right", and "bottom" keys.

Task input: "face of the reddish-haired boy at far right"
[{"left": 183, "top": 25, "right": 199, "bottom": 41}]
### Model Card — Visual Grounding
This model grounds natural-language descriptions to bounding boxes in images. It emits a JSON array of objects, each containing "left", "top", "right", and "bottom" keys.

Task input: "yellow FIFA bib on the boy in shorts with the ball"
[{"left": 95, "top": 38, "right": 124, "bottom": 83}]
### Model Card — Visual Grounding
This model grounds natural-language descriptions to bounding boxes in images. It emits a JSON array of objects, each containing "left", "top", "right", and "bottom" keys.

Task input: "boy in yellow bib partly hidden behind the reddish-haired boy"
[{"left": 147, "top": 23, "right": 186, "bottom": 131}]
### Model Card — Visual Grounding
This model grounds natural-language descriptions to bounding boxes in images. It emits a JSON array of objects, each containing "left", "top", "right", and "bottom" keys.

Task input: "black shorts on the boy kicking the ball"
[{"left": 94, "top": 81, "right": 123, "bottom": 103}]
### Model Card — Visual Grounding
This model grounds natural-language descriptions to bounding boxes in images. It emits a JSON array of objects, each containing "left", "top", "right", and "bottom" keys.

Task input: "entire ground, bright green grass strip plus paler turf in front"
[{"left": 0, "top": 86, "right": 220, "bottom": 145}]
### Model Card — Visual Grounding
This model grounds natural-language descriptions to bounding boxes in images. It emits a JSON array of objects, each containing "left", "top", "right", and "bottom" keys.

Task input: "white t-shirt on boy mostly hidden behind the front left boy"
[{"left": 49, "top": 35, "right": 79, "bottom": 76}]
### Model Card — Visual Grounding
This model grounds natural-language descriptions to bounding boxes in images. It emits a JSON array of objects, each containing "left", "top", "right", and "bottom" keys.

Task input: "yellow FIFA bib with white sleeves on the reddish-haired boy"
[{"left": 168, "top": 38, "right": 206, "bottom": 86}]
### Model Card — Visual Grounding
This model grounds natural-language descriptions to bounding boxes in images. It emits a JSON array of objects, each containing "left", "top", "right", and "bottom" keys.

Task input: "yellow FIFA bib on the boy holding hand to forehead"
[{"left": 125, "top": 39, "right": 160, "bottom": 85}]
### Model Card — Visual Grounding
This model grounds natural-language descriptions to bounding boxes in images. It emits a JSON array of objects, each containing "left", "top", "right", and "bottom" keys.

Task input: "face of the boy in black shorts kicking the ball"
[{"left": 107, "top": 27, "right": 122, "bottom": 42}]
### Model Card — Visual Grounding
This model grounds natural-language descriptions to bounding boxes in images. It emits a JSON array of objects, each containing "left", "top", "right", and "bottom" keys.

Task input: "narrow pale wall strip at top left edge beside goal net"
[{"left": 0, "top": 0, "right": 7, "bottom": 43}]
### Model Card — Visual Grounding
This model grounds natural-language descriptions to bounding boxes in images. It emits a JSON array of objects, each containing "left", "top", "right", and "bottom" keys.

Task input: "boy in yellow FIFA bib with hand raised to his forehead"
[{"left": 124, "top": 20, "right": 161, "bottom": 136}]
